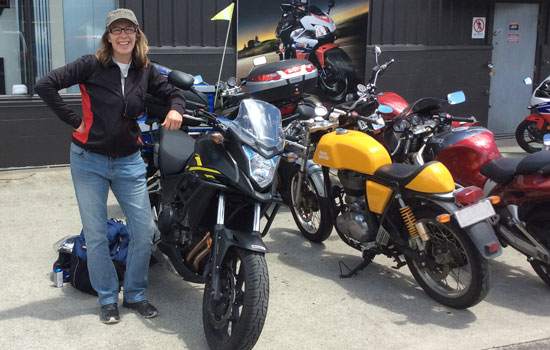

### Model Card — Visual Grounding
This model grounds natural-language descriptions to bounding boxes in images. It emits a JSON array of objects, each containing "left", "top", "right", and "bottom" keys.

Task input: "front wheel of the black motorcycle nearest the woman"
[{"left": 202, "top": 247, "right": 269, "bottom": 350}]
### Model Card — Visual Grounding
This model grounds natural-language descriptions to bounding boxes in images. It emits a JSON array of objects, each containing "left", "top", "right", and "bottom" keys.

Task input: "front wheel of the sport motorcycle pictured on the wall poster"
[{"left": 320, "top": 49, "right": 354, "bottom": 101}]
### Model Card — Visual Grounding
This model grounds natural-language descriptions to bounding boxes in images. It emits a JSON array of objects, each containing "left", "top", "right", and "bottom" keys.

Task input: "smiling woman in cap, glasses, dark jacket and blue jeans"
[{"left": 35, "top": 9, "right": 185, "bottom": 324}]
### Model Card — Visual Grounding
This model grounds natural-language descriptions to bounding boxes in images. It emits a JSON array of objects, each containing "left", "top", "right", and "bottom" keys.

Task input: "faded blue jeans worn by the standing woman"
[{"left": 71, "top": 143, "right": 155, "bottom": 306}]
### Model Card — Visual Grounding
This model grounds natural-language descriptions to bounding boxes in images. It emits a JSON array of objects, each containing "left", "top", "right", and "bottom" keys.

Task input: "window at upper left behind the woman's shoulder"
[{"left": 0, "top": 0, "right": 118, "bottom": 95}]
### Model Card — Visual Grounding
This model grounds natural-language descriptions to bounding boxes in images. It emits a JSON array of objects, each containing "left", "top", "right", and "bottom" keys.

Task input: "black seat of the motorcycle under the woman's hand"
[{"left": 158, "top": 128, "right": 195, "bottom": 174}]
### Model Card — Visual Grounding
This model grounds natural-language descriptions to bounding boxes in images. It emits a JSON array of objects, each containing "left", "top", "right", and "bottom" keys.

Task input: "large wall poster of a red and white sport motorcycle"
[{"left": 237, "top": 0, "right": 369, "bottom": 103}]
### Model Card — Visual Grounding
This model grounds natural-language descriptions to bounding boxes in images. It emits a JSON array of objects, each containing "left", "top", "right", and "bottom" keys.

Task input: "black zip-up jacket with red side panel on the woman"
[{"left": 35, "top": 55, "right": 185, "bottom": 157}]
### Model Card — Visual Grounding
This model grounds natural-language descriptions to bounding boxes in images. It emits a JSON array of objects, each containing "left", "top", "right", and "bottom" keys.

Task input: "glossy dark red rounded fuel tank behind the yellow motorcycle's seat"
[{"left": 423, "top": 126, "right": 502, "bottom": 188}]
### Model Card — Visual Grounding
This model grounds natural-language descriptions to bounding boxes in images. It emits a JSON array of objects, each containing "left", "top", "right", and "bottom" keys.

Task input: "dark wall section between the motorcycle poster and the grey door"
[{"left": 366, "top": 0, "right": 491, "bottom": 125}]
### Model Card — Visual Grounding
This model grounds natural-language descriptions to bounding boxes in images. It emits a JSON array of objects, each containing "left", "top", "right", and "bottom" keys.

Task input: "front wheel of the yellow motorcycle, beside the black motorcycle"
[{"left": 288, "top": 167, "right": 332, "bottom": 243}]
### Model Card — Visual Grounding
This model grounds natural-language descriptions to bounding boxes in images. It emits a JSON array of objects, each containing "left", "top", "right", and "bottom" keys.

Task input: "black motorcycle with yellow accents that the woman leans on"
[{"left": 148, "top": 99, "right": 284, "bottom": 349}]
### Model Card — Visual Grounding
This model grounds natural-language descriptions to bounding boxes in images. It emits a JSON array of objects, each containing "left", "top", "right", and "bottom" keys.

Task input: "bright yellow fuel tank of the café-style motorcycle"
[{"left": 313, "top": 130, "right": 391, "bottom": 175}]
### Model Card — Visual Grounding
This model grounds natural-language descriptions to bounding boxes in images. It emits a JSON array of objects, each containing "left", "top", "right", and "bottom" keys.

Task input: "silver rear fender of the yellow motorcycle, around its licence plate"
[{"left": 426, "top": 201, "right": 502, "bottom": 259}]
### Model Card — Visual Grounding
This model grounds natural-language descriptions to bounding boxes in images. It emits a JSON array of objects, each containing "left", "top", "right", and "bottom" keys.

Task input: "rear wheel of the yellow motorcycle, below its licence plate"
[{"left": 406, "top": 208, "right": 491, "bottom": 309}]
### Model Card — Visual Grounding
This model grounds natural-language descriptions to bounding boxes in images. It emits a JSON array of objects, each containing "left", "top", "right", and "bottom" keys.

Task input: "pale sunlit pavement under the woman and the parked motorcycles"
[{"left": 0, "top": 140, "right": 550, "bottom": 350}]
